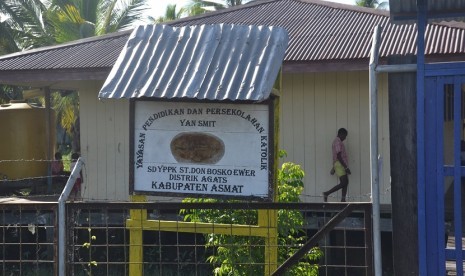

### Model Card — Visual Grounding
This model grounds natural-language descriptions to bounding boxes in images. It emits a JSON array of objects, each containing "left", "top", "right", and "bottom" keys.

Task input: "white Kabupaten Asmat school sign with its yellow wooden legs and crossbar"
[{"left": 126, "top": 94, "right": 279, "bottom": 275}]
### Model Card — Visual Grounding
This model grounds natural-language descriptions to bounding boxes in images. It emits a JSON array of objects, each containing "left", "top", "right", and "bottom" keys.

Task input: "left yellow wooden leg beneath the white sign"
[{"left": 129, "top": 195, "right": 147, "bottom": 276}]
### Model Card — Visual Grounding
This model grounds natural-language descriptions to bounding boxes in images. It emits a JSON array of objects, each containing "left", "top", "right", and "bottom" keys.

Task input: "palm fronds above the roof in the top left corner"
[{"left": 0, "top": 0, "right": 147, "bottom": 49}]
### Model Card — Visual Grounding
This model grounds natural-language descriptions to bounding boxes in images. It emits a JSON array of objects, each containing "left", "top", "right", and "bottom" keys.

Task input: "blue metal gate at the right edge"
[{"left": 426, "top": 63, "right": 465, "bottom": 275}]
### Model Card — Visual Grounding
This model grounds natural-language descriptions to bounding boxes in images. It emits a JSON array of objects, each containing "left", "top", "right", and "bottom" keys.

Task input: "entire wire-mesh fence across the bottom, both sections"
[{"left": 0, "top": 201, "right": 372, "bottom": 276}]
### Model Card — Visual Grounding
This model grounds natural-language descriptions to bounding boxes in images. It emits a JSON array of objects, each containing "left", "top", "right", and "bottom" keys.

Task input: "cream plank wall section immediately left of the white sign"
[{"left": 79, "top": 83, "right": 129, "bottom": 200}]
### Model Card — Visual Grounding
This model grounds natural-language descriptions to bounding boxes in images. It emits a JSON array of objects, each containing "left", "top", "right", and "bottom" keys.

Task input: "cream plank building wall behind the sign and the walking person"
[{"left": 79, "top": 71, "right": 390, "bottom": 203}]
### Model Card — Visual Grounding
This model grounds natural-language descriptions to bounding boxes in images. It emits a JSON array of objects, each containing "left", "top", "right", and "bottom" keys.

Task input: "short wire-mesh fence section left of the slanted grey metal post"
[{"left": 0, "top": 202, "right": 57, "bottom": 275}]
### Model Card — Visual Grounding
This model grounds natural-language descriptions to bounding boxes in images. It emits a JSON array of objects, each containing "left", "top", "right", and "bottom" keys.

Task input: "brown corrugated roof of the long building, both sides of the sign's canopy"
[{"left": 0, "top": 0, "right": 465, "bottom": 80}]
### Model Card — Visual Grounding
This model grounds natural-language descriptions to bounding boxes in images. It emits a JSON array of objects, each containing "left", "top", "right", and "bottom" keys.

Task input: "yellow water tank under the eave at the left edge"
[{"left": 0, "top": 101, "right": 55, "bottom": 180}]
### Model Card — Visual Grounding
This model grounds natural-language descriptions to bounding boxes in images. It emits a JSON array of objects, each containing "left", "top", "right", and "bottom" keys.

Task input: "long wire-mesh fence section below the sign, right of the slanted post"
[{"left": 66, "top": 202, "right": 373, "bottom": 275}]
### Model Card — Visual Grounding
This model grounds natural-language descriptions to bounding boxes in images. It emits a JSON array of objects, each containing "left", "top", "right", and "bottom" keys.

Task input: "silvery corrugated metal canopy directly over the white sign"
[{"left": 99, "top": 24, "right": 289, "bottom": 101}]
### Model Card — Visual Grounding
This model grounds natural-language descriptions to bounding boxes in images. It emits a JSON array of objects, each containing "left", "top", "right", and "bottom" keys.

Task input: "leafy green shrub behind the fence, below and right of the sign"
[{"left": 181, "top": 158, "right": 323, "bottom": 275}]
